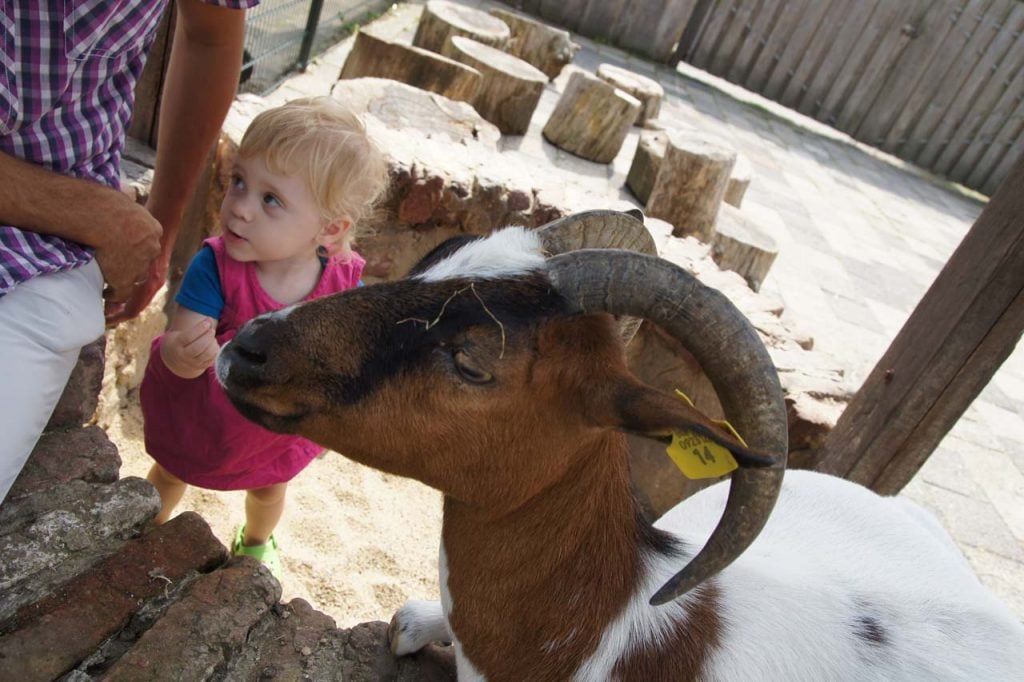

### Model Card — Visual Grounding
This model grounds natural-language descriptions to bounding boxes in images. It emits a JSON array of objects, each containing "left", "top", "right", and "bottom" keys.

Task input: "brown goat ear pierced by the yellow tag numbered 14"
[{"left": 613, "top": 382, "right": 774, "bottom": 466}]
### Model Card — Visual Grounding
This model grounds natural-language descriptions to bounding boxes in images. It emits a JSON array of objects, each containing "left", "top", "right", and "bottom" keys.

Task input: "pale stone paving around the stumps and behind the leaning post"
[{"left": 294, "top": 0, "right": 1024, "bottom": 617}]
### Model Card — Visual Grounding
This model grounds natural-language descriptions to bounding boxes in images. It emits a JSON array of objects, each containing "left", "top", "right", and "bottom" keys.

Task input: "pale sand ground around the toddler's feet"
[{"left": 100, "top": 390, "right": 441, "bottom": 628}]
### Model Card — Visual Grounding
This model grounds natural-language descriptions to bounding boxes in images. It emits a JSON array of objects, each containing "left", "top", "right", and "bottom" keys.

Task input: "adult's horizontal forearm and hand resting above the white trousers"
[{"left": 0, "top": 153, "right": 161, "bottom": 302}]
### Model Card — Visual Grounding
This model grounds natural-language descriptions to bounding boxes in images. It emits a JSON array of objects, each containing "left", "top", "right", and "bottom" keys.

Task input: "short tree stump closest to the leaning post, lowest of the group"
[{"left": 711, "top": 205, "right": 778, "bottom": 291}]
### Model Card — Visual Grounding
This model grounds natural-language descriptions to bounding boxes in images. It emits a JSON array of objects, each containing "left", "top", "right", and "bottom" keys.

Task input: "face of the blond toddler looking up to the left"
[{"left": 220, "top": 157, "right": 326, "bottom": 264}]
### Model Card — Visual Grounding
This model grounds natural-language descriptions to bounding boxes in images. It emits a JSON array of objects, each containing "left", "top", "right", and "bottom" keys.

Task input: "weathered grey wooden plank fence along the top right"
[{"left": 509, "top": 0, "right": 1024, "bottom": 195}]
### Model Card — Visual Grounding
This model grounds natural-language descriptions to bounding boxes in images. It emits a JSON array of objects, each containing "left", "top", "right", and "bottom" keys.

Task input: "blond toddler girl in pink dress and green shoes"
[{"left": 140, "top": 97, "right": 387, "bottom": 574}]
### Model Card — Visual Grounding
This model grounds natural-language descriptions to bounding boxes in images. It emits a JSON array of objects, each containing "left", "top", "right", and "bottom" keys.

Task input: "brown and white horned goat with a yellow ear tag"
[{"left": 216, "top": 209, "right": 1024, "bottom": 682}]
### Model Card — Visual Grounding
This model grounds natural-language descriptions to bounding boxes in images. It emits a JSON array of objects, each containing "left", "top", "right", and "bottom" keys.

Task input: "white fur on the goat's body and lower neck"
[{"left": 395, "top": 471, "right": 1024, "bottom": 682}]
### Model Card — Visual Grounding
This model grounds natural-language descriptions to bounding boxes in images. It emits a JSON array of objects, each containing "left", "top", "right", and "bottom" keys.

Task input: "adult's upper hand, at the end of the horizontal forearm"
[{"left": 94, "top": 193, "right": 164, "bottom": 314}]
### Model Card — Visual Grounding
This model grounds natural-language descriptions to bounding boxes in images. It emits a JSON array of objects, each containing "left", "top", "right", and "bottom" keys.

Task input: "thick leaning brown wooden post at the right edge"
[{"left": 814, "top": 159, "right": 1024, "bottom": 495}]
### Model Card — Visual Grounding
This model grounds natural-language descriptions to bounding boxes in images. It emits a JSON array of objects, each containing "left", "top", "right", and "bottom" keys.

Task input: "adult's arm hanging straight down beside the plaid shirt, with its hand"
[{"left": 108, "top": 0, "right": 245, "bottom": 324}]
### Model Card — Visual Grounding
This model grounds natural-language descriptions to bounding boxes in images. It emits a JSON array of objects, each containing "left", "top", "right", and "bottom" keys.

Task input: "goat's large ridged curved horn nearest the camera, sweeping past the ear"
[{"left": 548, "top": 249, "right": 788, "bottom": 605}]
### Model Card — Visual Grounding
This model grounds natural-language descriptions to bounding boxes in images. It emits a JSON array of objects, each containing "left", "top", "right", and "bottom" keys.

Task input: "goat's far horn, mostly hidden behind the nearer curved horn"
[{"left": 537, "top": 209, "right": 657, "bottom": 343}]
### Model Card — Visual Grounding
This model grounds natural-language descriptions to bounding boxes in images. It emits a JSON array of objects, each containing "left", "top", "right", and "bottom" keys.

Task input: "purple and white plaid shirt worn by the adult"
[{"left": 0, "top": 0, "right": 257, "bottom": 296}]
